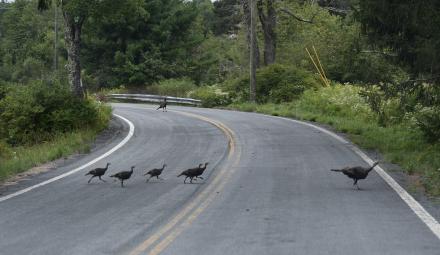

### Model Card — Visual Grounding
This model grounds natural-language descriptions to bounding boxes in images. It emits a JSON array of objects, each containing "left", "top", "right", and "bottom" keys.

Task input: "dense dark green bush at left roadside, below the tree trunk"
[{"left": 0, "top": 82, "right": 110, "bottom": 145}]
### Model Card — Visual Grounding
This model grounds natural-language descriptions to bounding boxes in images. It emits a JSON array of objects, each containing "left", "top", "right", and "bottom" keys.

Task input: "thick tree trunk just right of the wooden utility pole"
[{"left": 257, "top": 0, "right": 277, "bottom": 65}]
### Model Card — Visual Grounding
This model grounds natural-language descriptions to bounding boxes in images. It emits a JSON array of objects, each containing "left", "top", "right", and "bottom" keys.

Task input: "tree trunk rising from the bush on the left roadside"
[{"left": 63, "top": 11, "right": 85, "bottom": 99}]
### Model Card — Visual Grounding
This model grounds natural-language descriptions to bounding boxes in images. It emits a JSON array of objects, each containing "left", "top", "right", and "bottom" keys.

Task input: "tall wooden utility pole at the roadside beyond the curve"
[{"left": 249, "top": 0, "right": 257, "bottom": 103}]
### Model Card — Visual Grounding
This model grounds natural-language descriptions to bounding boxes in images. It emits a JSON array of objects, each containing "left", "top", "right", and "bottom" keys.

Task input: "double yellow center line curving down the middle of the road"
[{"left": 129, "top": 111, "right": 241, "bottom": 255}]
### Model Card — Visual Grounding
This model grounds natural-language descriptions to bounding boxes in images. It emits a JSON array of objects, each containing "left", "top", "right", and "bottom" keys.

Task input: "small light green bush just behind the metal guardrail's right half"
[{"left": 147, "top": 78, "right": 197, "bottom": 97}]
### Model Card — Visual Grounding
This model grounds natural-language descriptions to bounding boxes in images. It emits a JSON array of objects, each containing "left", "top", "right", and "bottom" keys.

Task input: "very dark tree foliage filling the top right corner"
[{"left": 358, "top": 0, "right": 440, "bottom": 80}]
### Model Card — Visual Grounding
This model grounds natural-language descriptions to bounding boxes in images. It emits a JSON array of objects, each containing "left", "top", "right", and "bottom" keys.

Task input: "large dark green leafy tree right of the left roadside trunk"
[{"left": 82, "top": 0, "right": 204, "bottom": 87}]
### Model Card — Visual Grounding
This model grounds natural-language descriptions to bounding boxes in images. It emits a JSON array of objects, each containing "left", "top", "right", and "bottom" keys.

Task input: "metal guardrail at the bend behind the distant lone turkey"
[{"left": 109, "top": 94, "right": 202, "bottom": 106}]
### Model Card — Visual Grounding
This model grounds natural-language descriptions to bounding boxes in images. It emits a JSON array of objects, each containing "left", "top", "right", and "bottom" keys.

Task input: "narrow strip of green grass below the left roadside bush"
[{"left": 0, "top": 102, "right": 111, "bottom": 181}]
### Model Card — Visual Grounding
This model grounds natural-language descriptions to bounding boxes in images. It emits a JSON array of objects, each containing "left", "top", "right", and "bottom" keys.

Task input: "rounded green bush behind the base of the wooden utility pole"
[{"left": 225, "top": 64, "right": 320, "bottom": 103}]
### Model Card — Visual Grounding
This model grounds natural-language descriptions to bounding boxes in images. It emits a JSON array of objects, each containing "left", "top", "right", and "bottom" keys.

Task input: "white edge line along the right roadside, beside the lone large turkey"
[{"left": 276, "top": 116, "right": 440, "bottom": 239}]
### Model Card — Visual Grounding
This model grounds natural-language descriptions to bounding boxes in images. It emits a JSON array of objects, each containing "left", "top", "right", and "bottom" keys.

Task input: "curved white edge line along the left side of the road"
[{"left": 0, "top": 113, "right": 134, "bottom": 202}]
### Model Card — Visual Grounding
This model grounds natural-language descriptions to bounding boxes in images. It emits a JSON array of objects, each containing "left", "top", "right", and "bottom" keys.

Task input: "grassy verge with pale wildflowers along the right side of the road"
[{"left": 228, "top": 85, "right": 440, "bottom": 197}]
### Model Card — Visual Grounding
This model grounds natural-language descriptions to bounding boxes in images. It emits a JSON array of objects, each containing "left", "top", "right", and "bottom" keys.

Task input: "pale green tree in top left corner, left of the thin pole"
[{"left": 0, "top": 0, "right": 62, "bottom": 83}]
